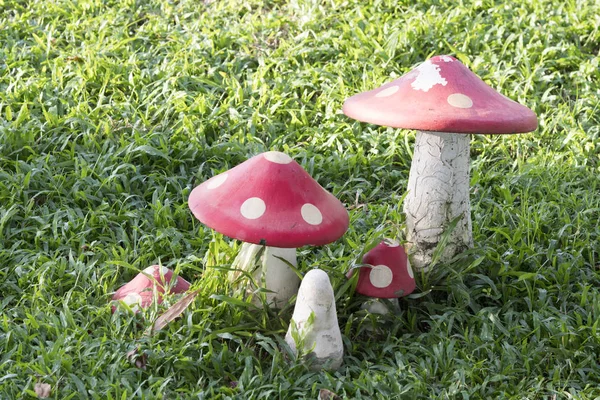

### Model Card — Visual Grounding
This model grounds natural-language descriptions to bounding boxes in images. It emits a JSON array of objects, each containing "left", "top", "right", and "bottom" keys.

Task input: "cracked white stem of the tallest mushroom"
[{"left": 404, "top": 131, "right": 473, "bottom": 270}]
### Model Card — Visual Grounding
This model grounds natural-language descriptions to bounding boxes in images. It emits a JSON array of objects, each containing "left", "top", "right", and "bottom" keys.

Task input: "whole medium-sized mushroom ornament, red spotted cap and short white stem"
[{"left": 189, "top": 151, "right": 349, "bottom": 308}]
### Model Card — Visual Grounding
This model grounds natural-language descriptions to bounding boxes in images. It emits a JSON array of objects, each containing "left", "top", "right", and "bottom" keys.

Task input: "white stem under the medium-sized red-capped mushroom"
[{"left": 230, "top": 243, "right": 300, "bottom": 308}]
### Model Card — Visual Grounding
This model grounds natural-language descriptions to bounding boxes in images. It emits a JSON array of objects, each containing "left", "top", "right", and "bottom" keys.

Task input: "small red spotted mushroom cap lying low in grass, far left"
[{"left": 112, "top": 265, "right": 190, "bottom": 313}]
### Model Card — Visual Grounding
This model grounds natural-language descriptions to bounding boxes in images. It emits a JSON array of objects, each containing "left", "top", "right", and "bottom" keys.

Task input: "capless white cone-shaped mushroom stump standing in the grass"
[{"left": 285, "top": 269, "right": 344, "bottom": 371}]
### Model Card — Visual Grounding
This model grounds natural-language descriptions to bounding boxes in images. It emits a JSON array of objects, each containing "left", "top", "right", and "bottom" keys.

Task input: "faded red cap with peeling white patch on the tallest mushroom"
[{"left": 343, "top": 56, "right": 537, "bottom": 133}]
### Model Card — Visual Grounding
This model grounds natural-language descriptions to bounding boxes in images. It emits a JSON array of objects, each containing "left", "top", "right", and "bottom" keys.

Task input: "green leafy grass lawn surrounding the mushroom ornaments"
[{"left": 0, "top": 0, "right": 600, "bottom": 399}]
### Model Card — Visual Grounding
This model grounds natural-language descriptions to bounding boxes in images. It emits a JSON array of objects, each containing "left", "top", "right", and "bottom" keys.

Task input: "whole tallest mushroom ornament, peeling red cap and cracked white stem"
[{"left": 343, "top": 56, "right": 537, "bottom": 269}]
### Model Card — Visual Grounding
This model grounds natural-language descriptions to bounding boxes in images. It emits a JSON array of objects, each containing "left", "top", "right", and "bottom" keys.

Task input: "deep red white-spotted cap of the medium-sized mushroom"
[{"left": 188, "top": 151, "right": 349, "bottom": 248}]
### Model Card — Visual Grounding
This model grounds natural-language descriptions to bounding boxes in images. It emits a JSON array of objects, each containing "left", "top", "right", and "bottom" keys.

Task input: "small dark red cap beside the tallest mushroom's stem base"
[{"left": 349, "top": 240, "right": 415, "bottom": 299}]
